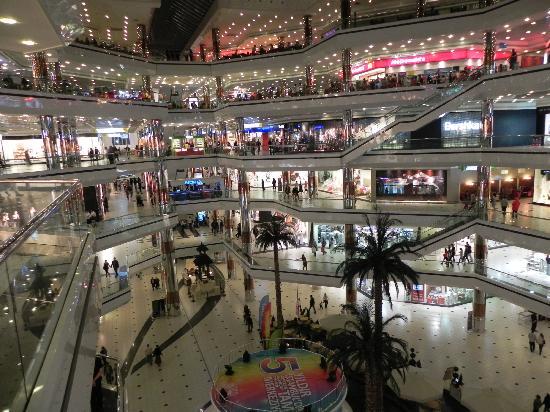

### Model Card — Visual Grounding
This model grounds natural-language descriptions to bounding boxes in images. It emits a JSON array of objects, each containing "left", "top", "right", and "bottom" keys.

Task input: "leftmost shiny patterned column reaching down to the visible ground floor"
[{"left": 149, "top": 119, "right": 180, "bottom": 310}]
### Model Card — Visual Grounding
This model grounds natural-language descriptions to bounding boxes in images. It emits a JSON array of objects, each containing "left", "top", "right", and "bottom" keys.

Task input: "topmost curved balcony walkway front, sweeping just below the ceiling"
[{"left": 52, "top": 0, "right": 548, "bottom": 76}]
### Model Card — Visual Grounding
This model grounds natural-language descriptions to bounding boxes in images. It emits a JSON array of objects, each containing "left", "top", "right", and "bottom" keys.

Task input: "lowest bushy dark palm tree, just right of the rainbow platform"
[{"left": 327, "top": 302, "right": 408, "bottom": 412}]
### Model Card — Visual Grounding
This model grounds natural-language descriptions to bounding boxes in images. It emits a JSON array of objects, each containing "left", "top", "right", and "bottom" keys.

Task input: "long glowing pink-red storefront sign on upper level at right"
[{"left": 351, "top": 49, "right": 510, "bottom": 75}]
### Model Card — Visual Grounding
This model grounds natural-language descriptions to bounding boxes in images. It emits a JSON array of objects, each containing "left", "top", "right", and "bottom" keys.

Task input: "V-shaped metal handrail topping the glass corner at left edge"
[{"left": 0, "top": 179, "right": 80, "bottom": 263}]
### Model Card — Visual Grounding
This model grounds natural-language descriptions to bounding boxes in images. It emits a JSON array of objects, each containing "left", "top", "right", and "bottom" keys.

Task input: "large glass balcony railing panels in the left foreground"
[{"left": 0, "top": 180, "right": 90, "bottom": 411}]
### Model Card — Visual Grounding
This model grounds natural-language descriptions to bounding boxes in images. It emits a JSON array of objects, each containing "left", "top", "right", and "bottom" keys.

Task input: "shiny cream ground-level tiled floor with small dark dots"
[{"left": 98, "top": 243, "right": 550, "bottom": 411}]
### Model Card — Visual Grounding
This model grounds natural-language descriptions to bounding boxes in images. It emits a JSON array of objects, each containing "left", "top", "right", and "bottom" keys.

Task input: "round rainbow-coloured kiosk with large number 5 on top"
[{"left": 210, "top": 340, "right": 347, "bottom": 412}]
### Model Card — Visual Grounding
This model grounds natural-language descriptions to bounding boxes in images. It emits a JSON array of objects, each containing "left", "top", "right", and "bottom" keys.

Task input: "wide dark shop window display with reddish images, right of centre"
[{"left": 376, "top": 169, "right": 447, "bottom": 200}]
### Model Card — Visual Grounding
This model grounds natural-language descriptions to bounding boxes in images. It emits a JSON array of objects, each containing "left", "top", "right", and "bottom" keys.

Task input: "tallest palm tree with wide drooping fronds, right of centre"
[{"left": 336, "top": 213, "right": 418, "bottom": 410}]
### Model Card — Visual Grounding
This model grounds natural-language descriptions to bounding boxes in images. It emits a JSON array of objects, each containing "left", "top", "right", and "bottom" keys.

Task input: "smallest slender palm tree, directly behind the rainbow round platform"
[{"left": 256, "top": 216, "right": 296, "bottom": 328}]
